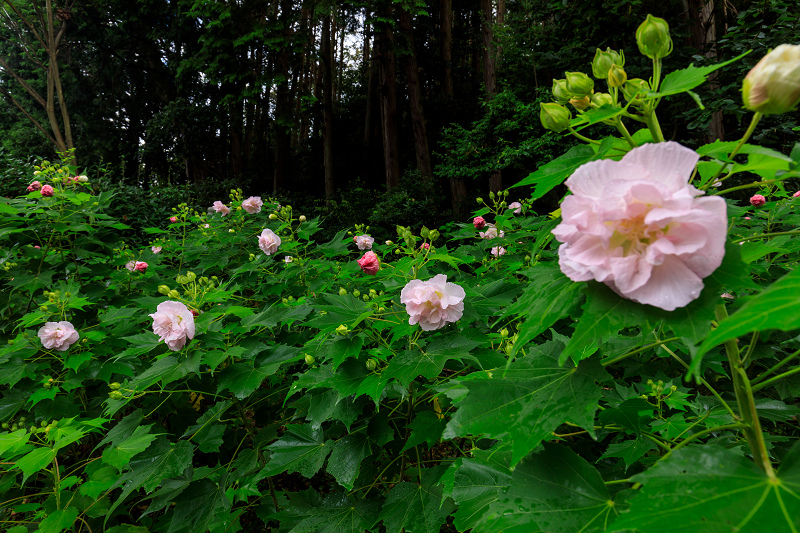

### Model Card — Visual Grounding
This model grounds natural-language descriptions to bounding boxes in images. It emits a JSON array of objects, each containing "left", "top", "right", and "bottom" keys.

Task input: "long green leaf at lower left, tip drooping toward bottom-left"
[{"left": 106, "top": 437, "right": 194, "bottom": 521}]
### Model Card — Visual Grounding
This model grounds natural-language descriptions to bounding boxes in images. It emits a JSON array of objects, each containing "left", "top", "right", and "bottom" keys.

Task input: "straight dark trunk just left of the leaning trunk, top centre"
[{"left": 378, "top": 5, "right": 400, "bottom": 189}]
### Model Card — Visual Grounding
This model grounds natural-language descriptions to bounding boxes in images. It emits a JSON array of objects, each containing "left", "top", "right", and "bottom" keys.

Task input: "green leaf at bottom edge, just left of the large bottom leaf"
[{"left": 452, "top": 447, "right": 512, "bottom": 531}]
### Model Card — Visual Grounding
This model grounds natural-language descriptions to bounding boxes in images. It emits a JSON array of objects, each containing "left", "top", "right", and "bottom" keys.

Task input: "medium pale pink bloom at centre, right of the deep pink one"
[{"left": 400, "top": 274, "right": 466, "bottom": 331}]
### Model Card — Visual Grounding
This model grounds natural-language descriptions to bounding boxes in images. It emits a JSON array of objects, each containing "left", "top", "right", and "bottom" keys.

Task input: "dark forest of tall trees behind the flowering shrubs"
[{"left": 0, "top": 0, "right": 800, "bottom": 238}]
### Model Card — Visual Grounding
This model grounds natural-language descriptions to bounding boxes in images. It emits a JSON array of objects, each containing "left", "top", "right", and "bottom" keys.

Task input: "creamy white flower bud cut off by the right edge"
[{"left": 742, "top": 44, "right": 800, "bottom": 115}]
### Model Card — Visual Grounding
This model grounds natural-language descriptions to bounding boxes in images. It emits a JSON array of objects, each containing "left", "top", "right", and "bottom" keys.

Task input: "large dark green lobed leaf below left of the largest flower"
[{"left": 444, "top": 341, "right": 607, "bottom": 465}]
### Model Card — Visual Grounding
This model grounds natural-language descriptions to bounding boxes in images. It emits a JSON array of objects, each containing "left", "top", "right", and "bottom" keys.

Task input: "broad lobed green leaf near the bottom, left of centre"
[{"left": 259, "top": 424, "right": 333, "bottom": 478}]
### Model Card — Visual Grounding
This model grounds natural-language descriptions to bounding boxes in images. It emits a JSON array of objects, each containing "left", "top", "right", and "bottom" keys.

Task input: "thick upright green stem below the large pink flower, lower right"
[{"left": 715, "top": 305, "right": 775, "bottom": 478}]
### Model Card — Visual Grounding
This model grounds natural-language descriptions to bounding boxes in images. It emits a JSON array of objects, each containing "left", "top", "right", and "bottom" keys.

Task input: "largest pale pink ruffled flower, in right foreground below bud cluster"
[{"left": 553, "top": 142, "right": 728, "bottom": 311}]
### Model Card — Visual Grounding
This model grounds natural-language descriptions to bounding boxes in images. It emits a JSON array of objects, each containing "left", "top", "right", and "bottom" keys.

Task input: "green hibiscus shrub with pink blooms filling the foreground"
[{"left": 0, "top": 18, "right": 800, "bottom": 533}]
